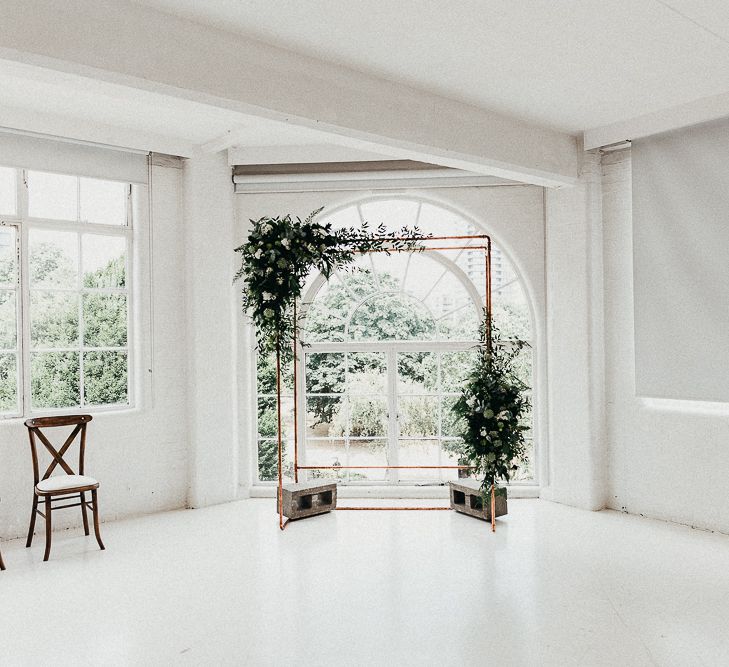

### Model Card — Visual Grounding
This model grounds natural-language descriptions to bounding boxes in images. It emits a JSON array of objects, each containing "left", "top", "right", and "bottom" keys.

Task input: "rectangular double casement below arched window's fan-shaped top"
[{"left": 297, "top": 341, "right": 477, "bottom": 485}]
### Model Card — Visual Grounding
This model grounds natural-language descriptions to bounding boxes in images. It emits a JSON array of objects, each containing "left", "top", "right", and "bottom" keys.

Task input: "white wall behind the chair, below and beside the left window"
[{"left": 0, "top": 162, "right": 188, "bottom": 539}]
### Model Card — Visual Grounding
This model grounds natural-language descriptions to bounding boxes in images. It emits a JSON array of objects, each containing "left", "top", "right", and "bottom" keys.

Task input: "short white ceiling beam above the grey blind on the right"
[{"left": 584, "top": 92, "right": 729, "bottom": 151}]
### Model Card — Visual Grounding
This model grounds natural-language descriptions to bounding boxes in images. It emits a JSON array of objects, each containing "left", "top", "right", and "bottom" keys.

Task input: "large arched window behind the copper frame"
[{"left": 258, "top": 199, "right": 534, "bottom": 485}]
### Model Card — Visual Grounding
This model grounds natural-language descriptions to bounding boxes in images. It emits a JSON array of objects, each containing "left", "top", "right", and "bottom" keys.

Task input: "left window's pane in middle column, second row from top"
[{"left": 28, "top": 229, "right": 78, "bottom": 289}]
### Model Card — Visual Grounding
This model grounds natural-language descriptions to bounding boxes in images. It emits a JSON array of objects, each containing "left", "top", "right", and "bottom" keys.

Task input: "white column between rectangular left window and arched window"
[{"left": 180, "top": 153, "right": 238, "bottom": 507}]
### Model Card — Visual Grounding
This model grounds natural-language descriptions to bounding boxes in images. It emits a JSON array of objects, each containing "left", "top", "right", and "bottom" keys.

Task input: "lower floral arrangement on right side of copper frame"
[{"left": 453, "top": 318, "right": 531, "bottom": 496}]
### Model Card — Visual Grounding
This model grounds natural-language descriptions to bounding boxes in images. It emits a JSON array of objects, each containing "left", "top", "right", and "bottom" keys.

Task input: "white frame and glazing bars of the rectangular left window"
[{"left": 0, "top": 168, "right": 136, "bottom": 420}]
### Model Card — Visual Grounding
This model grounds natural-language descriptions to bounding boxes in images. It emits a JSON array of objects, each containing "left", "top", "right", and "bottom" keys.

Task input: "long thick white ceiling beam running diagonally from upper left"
[{"left": 0, "top": 0, "right": 577, "bottom": 186}]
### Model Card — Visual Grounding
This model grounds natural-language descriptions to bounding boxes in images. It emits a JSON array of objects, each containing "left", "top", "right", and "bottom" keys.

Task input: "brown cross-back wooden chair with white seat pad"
[{"left": 25, "top": 415, "right": 104, "bottom": 561}]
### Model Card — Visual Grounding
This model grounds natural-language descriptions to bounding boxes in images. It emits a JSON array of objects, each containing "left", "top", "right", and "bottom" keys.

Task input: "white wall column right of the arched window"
[{"left": 542, "top": 153, "right": 607, "bottom": 510}]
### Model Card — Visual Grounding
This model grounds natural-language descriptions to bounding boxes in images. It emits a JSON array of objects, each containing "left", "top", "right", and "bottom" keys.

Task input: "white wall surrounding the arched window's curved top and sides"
[{"left": 236, "top": 186, "right": 549, "bottom": 484}]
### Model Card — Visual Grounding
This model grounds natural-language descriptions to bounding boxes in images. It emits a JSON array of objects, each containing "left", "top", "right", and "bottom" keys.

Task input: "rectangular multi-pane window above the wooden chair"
[{"left": 0, "top": 168, "right": 132, "bottom": 416}]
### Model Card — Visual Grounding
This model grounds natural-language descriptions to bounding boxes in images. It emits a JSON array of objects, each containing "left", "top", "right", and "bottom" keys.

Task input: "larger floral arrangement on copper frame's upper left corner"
[{"left": 235, "top": 208, "right": 424, "bottom": 352}]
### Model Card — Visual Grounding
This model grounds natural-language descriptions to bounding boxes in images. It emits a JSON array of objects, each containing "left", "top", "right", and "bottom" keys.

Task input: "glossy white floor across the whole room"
[{"left": 0, "top": 500, "right": 729, "bottom": 667}]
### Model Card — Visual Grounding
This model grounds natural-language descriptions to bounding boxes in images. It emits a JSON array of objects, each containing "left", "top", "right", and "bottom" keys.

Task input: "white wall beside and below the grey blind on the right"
[{"left": 602, "top": 150, "right": 729, "bottom": 533}]
